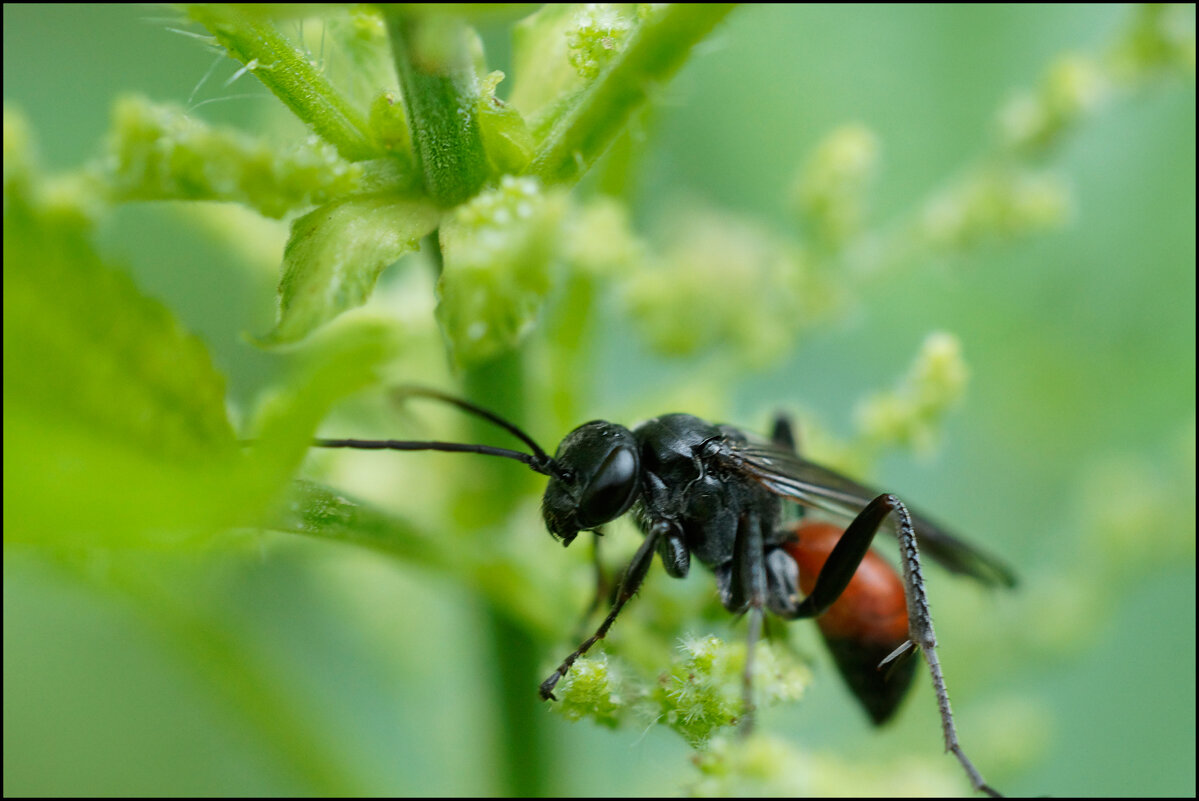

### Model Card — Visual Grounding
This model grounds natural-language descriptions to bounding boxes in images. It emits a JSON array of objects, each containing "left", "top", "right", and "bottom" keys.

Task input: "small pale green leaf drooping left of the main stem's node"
[{"left": 263, "top": 194, "right": 440, "bottom": 344}]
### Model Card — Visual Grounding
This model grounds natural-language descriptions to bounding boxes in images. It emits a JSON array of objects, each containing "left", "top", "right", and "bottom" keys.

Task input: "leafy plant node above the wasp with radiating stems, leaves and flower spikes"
[{"left": 157, "top": 5, "right": 728, "bottom": 352}]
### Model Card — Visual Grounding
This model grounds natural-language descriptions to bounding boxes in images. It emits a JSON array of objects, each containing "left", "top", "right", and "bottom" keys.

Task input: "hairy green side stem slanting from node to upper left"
[{"left": 185, "top": 4, "right": 376, "bottom": 162}]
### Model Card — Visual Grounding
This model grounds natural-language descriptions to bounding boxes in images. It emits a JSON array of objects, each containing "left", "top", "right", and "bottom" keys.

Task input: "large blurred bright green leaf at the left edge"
[{"left": 4, "top": 181, "right": 245, "bottom": 544}]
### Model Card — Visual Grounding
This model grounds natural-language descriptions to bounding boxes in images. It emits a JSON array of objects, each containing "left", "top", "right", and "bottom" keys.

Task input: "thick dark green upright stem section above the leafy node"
[{"left": 387, "top": 12, "right": 488, "bottom": 206}]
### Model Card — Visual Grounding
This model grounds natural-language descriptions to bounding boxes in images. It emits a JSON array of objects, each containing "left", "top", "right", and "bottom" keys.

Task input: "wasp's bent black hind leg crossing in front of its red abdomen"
[{"left": 784, "top": 494, "right": 999, "bottom": 796}]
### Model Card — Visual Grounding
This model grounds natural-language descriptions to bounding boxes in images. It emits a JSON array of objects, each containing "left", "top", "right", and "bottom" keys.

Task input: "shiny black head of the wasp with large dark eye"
[{"left": 542, "top": 420, "right": 641, "bottom": 544}]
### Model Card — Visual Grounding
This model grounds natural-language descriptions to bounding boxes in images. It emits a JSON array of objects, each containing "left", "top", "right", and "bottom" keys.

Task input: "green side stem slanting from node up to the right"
[{"left": 528, "top": 2, "right": 734, "bottom": 183}]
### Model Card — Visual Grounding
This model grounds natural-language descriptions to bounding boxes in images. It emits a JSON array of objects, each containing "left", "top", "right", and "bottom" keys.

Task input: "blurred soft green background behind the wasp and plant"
[{"left": 4, "top": 5, "right": 1195, "bottom": 796}]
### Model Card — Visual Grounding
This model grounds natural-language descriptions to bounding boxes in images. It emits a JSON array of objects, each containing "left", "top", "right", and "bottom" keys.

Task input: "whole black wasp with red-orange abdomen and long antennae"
[{"left": 315, "top": 389, "right": 1016, "bottom": 795}]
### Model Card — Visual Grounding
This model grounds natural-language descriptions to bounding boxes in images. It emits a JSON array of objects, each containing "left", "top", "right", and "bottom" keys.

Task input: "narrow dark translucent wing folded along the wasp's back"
[{"left": 719, "top": 440, "right": 1016, "bottom": 586}]
